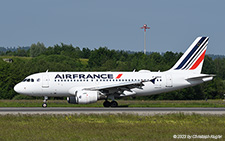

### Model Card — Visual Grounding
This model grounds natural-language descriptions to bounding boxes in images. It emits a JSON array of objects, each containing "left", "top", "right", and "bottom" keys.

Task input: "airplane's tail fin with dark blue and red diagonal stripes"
[{"left": 170, "top": 37, "right": 209, "bottom": 74}]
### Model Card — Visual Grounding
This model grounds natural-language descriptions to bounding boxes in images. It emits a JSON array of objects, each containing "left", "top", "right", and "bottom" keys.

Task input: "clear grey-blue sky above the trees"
[{"left": 0, "top": 0, "right": 225, "bottom": 55}]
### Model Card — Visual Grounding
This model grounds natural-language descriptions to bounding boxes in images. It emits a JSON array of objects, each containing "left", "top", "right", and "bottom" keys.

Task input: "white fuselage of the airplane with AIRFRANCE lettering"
[{"left": 15, "top": 70, "right": 212, "bottom": 97}]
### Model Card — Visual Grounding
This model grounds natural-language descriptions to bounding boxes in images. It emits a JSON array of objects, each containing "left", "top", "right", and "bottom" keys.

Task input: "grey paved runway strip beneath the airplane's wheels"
[{"left": 0, "top": 107, "right": 225, "bottom": 115}]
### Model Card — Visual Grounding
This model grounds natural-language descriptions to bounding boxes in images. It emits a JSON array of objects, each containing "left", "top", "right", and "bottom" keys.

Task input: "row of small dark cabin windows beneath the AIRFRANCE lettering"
[{"left": 55, "top": 79, "right": 162, "bottom": 82}]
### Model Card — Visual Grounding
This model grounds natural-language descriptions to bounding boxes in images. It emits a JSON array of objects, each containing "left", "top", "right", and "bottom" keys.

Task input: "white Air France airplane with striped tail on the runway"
[{"left": 14, "top": 37, "right": 214, "bottom": 107}]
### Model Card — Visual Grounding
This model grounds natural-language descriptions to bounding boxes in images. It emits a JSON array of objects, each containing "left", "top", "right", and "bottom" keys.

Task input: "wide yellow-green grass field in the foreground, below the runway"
[{"left": 0, "top": 113, "right": 225, "bottom": 140}]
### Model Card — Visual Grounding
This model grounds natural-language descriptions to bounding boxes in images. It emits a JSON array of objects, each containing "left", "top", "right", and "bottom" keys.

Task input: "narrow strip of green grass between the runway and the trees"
[{"left": 0, "top": 100, "right": 225, "bottom": 108}]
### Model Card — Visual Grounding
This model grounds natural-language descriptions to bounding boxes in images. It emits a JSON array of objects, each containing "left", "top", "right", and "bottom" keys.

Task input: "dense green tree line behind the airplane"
[{"left": 0, "top": 42, "right": 225, "bottom": 100}]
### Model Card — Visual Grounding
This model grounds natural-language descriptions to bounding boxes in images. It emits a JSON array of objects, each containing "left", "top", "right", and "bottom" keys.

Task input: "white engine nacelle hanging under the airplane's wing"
[{"left": 67, "top": 91, "right": 101, "bottom": 104}]
